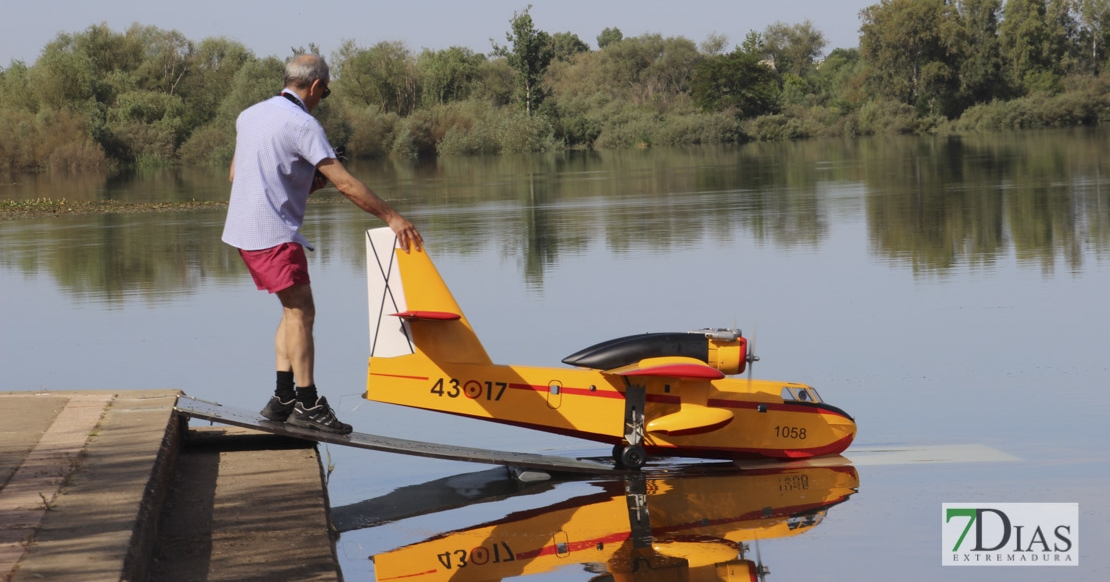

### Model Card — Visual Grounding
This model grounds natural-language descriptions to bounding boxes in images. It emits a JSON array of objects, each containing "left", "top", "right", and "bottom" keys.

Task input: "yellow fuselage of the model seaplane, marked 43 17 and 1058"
[{"left": 366, "top": 353, "right": 856, "bottom": 459}]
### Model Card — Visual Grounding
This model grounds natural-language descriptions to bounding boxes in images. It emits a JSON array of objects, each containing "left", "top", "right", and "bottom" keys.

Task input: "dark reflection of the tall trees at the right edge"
[{"left": 860, "top": 130, "right": 1110, "bottom": 273}]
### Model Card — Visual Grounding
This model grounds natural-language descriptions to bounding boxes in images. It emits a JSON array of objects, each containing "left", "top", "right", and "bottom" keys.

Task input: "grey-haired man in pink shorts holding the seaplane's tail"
[{"left": 223, "top": 54, "right": 423, "bottom": 434}]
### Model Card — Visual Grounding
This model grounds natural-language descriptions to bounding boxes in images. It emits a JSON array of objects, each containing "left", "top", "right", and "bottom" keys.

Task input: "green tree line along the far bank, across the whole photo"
[{"left": 0, "top": 0, "right": 1110, "bottom": 172}]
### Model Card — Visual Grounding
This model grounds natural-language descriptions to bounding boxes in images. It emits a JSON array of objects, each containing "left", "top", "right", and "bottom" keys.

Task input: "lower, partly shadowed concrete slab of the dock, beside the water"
[{"left": 149, "top": 427, "right": 342, "bottom": 581}]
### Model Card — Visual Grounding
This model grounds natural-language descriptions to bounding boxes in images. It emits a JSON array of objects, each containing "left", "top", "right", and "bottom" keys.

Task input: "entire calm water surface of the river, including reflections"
[{"left": 0, "top": 131, "right": 1110, "bottom": 581}]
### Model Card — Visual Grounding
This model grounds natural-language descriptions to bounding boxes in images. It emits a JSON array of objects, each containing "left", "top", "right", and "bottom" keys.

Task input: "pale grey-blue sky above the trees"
[{"left": 0, "top": 0, "right": 878, "bottom": 68}]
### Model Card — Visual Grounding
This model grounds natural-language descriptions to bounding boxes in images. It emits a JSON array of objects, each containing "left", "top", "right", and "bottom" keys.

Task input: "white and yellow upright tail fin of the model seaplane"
[{"left": 366, "top": 228, "right": 493, "bottom": 364}]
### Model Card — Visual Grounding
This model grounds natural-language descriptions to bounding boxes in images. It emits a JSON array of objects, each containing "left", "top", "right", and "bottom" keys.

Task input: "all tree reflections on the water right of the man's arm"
[{"left": 313, "top": 130, "right": 1110, "bottom": 284}]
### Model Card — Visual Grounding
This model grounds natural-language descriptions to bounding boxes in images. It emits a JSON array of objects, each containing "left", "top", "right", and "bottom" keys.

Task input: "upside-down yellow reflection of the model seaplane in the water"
[{"left": 350, "top": 465, "right": 859, "bottom": 582}]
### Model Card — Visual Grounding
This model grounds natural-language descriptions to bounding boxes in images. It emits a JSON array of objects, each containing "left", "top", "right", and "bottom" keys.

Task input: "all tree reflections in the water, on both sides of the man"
[{"left": 0, "top": 130, "right": 1110, "bottom": 301}]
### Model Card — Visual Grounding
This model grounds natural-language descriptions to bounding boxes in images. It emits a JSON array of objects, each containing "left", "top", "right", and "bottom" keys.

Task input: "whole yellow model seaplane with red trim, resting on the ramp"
[{"left": 366, "top": 228, "right": 856, "bottom": 469}]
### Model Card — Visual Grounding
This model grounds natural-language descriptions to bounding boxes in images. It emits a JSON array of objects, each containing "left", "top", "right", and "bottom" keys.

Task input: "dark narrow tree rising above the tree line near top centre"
[{"left": 491, "top": 4, "right": 555, "bottom": 116}]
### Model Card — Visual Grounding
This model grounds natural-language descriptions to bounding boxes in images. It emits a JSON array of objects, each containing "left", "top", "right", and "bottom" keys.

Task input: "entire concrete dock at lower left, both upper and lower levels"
[{"left": 0, "top": 390, "right": 342, "bottom": 582}]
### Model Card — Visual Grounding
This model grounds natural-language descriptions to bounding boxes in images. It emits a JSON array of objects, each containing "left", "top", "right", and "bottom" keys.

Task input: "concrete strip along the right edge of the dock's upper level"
[{"left": 2, "top": 390, "right": 181, "bottom": 581}]
